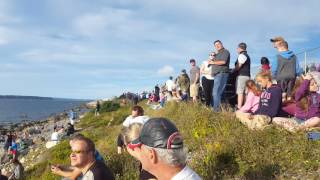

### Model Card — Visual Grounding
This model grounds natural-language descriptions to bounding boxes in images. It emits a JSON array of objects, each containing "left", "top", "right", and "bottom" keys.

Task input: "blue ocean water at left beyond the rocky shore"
[{"left": 0, "top": 98, "right": 88, "bottom": 124}]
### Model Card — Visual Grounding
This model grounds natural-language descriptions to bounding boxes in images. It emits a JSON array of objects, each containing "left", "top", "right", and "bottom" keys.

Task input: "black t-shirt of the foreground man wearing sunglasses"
[{"left": 78, "top": 161, "right": 115, "bottom": 180}]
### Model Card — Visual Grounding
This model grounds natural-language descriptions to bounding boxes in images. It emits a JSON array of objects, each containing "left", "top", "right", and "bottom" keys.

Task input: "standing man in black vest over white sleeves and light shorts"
[{"left": 235, "top": 42, "right": 251, "bottom": 109}]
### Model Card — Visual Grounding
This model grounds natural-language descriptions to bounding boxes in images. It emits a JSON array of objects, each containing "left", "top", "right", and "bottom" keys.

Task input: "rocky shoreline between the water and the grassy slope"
[{"left": 0, "top": 104, "right": 90, "bottom": 172}]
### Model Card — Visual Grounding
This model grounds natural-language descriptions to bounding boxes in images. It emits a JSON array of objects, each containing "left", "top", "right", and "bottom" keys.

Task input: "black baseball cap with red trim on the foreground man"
[{"left": 128, "top": 117, "right": 183, "bottom": 149}]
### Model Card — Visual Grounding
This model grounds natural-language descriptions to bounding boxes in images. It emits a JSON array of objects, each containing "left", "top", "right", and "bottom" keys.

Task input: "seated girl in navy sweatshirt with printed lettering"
[{"left": 237, "top": 72, "right": 282, "bottom": 129}]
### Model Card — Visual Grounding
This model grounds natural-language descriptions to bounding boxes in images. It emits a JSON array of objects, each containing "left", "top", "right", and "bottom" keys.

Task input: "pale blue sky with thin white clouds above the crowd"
[{"left": 0, "top": 0, "right": 320, "bottom": 99}]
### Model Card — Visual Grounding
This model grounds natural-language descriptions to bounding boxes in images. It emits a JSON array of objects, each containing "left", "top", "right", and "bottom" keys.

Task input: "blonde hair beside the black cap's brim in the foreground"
[{"left": 121, "top": 123, "right": 142, "bottom": 145}]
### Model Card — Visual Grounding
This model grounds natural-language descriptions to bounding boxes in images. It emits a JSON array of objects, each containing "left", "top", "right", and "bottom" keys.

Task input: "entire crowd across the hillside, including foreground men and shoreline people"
[{"left": 0, "top": 37, "right": 320, "bottom": 180}]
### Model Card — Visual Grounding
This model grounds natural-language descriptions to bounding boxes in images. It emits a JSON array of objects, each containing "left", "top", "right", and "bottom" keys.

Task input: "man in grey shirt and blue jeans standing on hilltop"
[{"left": 209, "top": 40, "right": 230, "bottom": 111}]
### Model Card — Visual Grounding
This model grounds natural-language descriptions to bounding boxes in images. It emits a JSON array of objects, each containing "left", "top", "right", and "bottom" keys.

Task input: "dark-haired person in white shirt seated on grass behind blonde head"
[{"left": 117, "top": 106, "right": 149, "bottom": 154}]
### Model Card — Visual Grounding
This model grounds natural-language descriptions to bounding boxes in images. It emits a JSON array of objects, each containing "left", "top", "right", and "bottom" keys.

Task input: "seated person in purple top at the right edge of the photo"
[{"left": 273, "top": 72, "right": 320, "bottom": 131}]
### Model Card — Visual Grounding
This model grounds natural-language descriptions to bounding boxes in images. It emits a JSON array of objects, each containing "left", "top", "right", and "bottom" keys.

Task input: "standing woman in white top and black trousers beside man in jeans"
[{"left": 200, "top": 53, "right": 214, "bottom": 107}]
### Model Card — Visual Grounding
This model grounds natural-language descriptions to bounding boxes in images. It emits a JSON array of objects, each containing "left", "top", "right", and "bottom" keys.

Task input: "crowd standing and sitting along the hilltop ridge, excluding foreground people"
[{"left": 144, "top": 37, "right": 320, "bottom": 131}]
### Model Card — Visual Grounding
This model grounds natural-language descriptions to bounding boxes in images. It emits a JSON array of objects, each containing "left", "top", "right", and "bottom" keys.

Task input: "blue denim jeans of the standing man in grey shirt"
[{"left": 212, "top": 73, "right": 229, "bottom": 111}]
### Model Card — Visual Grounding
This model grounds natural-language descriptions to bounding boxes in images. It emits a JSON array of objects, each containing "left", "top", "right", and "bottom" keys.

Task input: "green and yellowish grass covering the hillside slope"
[{"left": 28, "top": 100, "right": 320, "bottom": 180}]
